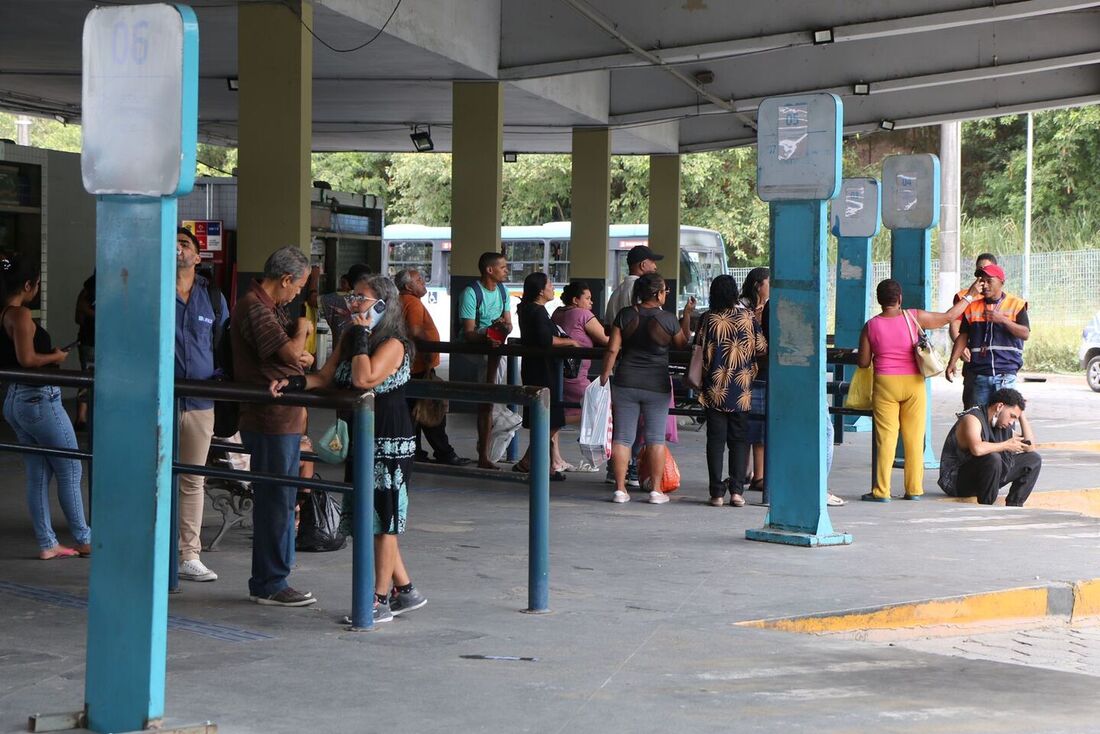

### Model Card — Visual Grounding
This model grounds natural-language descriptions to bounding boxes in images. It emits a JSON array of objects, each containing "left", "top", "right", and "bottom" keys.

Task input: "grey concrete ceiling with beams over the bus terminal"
[{"left": 0, "top": 0, "right": 1100, "bottom": 153}]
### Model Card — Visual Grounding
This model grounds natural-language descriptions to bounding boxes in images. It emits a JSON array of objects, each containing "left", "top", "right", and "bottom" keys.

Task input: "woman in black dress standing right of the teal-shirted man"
[{"left": 513, "top": 273, "right": 580, "bottom": 482}]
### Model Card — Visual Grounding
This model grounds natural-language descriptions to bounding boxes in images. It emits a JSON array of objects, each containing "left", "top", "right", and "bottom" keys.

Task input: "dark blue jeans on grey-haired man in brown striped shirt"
[{"left": 241, "top": 430, "right": 301, "bottom": 596}]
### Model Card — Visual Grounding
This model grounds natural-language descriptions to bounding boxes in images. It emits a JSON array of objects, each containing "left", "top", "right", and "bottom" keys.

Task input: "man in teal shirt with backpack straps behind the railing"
[{"left": 459, "top": 252, "right": 512, "bottom": 469}]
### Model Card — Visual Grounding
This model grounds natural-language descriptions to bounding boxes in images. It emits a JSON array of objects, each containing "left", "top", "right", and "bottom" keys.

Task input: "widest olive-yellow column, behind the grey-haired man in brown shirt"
[{"left": 237, "top": 0, "right": 314, "bottom": 273}]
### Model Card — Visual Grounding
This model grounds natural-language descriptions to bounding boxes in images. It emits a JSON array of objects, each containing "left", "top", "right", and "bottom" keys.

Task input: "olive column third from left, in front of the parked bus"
[{"left": 569, "top": 128, "right": 612, "bottom": 316}]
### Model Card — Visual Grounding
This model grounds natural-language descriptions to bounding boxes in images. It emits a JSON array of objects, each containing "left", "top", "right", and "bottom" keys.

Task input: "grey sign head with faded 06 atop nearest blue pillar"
[{"left": 80, "top": 4, "right": 199, "bottom": 196}]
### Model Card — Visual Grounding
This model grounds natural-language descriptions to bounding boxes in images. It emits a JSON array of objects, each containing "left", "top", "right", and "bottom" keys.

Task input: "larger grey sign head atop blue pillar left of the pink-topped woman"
[{"left": 757, "top": 94, "right": 844, "bottom": 201}]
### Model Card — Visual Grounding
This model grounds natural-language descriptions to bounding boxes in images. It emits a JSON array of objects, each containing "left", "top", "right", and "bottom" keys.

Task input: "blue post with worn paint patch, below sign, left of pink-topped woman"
[{"left": 745, "top": 200, "right": 851, "bottom": 546}]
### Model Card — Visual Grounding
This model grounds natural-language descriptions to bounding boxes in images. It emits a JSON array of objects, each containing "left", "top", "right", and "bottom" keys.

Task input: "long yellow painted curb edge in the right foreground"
[{"left": 735, "top": 579, "right": 1100, "bottom": 634}]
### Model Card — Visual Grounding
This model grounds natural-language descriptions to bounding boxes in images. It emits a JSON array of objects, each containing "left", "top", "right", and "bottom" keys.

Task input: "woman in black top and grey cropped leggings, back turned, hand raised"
[{"left": 600, "top": 273, "right": 695, "bottom": 505}]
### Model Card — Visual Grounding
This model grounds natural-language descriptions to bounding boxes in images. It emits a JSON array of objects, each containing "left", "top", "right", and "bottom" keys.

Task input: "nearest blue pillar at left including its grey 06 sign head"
[{"left": 80, "top": 4, "right": 198, "bottom": 732}]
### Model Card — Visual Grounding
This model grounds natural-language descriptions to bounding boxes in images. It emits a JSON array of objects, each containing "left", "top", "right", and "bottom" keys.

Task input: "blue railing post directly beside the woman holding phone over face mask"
[{"left": 344, "top": 394, "right": 375, "bottom": 629}]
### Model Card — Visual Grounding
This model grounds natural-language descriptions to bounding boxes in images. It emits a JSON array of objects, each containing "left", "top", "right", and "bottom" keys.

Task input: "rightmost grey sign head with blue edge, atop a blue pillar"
[{"left": 882, "top": 153, "right": 939, "bottom": 229}]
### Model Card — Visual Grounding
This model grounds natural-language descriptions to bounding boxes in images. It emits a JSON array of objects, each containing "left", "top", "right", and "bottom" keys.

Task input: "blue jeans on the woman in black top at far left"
[{"left": 3, "top": 385, "right": 91, "bottom": 550}]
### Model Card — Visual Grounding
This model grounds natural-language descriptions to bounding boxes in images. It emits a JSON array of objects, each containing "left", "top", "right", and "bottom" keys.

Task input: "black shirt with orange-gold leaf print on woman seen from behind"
[{"left": 695, "top": 306, "right": 768, "bottom": 413}]
